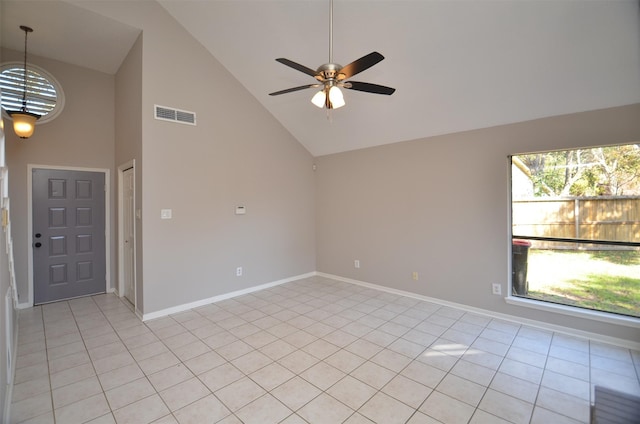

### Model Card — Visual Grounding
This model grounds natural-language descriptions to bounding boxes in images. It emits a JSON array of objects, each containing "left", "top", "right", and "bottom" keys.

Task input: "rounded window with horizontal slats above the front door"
[{"left": 0, "top": 62, "right": 64, "bottom": 123}]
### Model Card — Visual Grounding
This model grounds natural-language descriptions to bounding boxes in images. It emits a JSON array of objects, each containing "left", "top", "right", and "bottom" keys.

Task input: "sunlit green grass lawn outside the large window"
[{"left": 527, "top": 249, "right": 640, "bottom": 317}]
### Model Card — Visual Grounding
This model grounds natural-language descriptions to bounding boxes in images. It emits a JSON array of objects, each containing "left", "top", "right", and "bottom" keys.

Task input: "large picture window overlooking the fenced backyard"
[{"left": 511, "top": 144, "right": 640, "bottom": 317}]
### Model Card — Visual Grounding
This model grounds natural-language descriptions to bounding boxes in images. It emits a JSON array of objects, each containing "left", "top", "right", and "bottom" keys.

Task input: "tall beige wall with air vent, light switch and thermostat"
[{"left": 80, "top": 2, "right": 315, "bottom": 314}]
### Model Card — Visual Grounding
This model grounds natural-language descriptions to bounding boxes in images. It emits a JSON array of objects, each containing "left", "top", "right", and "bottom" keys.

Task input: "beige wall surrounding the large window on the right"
[{"left": 316, "top": 105, "right": 640, "bottom": 341}]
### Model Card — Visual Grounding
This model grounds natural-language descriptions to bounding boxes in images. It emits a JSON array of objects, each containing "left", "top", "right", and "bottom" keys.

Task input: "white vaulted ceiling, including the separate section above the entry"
[{"left": 2, "top": 0, "right": 640, "bottom": 156}]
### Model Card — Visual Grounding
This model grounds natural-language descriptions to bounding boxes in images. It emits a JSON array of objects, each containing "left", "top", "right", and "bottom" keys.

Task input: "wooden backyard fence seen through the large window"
[{"left": 512, "top": 196, "right": 640, "bottom": 248}]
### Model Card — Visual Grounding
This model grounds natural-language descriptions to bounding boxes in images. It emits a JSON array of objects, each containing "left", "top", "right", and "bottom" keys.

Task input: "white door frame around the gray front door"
[{"left": 26, "top": 164, "right": 113, "bottom": 308}]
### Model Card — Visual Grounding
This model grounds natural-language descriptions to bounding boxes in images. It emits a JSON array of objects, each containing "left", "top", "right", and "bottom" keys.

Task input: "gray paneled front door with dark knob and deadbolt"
[{"left": 32, "top": 168, "right": 106, "bottom": 305}]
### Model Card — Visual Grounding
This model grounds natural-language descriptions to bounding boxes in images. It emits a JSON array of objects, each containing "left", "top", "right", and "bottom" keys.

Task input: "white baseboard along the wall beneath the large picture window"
[{"left": 316, "top": 272, "right": 640, "bottom": 350}]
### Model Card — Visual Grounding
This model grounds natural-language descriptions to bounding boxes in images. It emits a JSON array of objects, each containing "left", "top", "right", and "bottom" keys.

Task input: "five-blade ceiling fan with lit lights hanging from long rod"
[{"left": 269, "top": 0, "right": 396, "bottom": 109}]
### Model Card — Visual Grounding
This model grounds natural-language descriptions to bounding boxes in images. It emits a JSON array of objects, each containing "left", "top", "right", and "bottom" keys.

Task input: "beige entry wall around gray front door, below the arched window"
[{"left": 2, "top": 50, "right": 115, "bottom": 303}]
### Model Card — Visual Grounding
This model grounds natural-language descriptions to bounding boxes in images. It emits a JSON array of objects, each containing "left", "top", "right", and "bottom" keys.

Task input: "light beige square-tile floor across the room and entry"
[{"left": 11, "top": 277, "right": 640, "bottom": 424}]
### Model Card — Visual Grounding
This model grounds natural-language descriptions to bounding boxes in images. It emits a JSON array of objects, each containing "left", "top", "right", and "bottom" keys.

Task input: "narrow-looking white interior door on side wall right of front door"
[{"left": 122, "top": 168, "right": 136, "bottom": 305}]
